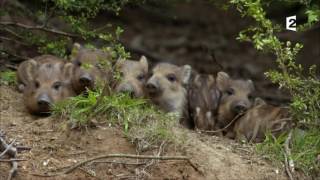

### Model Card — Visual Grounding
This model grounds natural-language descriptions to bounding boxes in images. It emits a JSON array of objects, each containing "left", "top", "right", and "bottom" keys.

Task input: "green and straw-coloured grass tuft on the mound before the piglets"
[{"left": 53, "top": 90, "right": 177, "bottom": 151}]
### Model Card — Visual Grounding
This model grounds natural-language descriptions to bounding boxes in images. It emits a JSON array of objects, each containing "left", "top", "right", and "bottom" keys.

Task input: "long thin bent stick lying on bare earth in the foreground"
[{"left": 31, "top": 154, "right": 192, "bottom": 177}]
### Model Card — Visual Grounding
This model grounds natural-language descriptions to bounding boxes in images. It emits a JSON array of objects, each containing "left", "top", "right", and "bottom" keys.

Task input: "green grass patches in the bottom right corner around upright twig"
[{"left": 256, "top": 128, "right": 320, "bottom": 176}]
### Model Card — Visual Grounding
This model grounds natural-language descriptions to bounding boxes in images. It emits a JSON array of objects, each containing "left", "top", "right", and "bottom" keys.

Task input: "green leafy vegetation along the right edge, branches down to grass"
[{"left": 230, "top": 0, "right": 320, "bottom": 175}]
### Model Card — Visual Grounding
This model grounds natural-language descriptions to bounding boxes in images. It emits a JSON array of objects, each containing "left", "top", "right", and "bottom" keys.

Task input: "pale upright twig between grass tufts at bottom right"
[{"left": 284, "top": 130, "right": 294, "bottom": 180}]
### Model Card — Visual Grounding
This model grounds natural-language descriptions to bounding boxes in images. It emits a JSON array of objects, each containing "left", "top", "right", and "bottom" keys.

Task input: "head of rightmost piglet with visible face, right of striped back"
[{"left": 217, "top": 72, "right": 254, "bottom": 138}]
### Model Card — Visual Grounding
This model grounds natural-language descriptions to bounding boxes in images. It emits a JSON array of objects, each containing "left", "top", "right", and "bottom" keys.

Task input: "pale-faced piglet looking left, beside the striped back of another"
[{"left": 146, "top": 63, "right": 191, "bottom": 116}]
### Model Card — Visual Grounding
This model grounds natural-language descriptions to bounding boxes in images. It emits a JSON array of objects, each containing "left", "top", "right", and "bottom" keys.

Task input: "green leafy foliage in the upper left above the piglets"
[{"left": 0, "top": 0, "right": 134, "bottom": 57}]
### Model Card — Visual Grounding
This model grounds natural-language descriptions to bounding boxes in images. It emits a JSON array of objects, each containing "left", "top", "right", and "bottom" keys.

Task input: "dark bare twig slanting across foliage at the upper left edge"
[{"left": 0, "top": 21, "right": 80, "bottom": 38}]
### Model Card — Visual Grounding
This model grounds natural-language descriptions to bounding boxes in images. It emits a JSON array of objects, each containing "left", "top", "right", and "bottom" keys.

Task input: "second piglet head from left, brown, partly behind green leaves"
[{"left": 71, "top": 43, "right": 111, "bottom": 94}]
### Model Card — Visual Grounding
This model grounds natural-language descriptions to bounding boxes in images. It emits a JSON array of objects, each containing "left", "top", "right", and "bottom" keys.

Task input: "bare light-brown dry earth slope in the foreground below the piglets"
[{"left": 0, "top": 86, "right": 286, "bottom": 180}]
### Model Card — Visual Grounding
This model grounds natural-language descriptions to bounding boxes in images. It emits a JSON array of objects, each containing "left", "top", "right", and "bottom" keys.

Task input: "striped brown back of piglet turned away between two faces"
[{"left": 188, "top": 74, "right": 220, "bottom": 130}]
